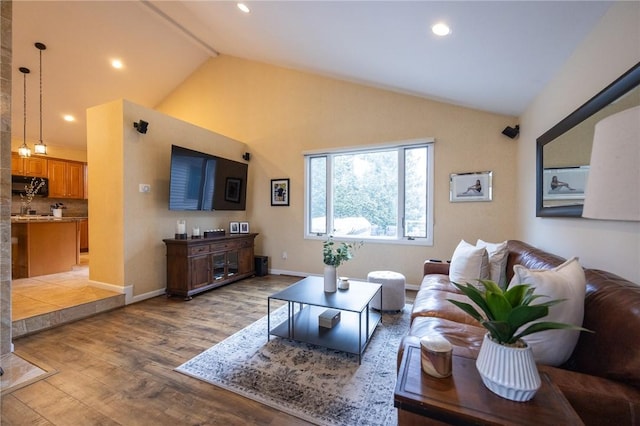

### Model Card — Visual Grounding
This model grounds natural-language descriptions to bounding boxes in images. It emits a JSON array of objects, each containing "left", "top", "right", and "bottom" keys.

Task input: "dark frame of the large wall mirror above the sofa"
[{"left": 536, "top": 62, "right": 640, "bottom": 217}]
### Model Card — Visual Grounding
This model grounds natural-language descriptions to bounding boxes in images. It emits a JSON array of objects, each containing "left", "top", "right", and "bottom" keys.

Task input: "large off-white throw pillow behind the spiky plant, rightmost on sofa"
[{"left": 509, "top": 257, "right": 586, "bottom": 366}]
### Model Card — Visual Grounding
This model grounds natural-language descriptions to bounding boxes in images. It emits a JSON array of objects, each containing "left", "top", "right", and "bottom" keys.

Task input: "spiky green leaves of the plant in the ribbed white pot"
[{"left": 447, "top": 280, "right": 589, "bottom": 347}]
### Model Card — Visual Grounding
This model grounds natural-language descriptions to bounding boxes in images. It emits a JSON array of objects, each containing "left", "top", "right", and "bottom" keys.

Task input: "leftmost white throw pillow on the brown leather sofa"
[{"left": 449, "top": 240, "right": 489, "bottom": 289}]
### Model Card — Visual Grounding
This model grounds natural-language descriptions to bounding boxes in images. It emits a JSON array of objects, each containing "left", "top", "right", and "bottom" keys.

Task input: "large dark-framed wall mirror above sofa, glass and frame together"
[{"left": 536, "top": 63, "right": 640, "bottom": 217}]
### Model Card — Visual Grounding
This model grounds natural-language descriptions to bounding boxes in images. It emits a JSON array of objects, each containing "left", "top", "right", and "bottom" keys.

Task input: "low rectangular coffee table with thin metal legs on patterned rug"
[{"left": 267, "top": 277, "right": 382, "bottom": 363}]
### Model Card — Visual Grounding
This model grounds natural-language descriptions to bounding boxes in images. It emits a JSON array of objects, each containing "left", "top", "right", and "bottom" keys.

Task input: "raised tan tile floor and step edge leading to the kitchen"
[{"left": 11, "top": 254, "right": 124, "bottom": 338}]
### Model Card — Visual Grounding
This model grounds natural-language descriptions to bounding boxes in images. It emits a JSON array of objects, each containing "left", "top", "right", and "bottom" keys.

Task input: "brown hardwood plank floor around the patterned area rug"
[{"left": 1, "top": 275, "right": 415, "bottom": 426}]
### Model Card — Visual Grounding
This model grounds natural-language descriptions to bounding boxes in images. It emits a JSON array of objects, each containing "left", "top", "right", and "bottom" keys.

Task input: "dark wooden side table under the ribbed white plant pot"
[{"left": 394, "top": 345, "right": 583, "bottom": 426}]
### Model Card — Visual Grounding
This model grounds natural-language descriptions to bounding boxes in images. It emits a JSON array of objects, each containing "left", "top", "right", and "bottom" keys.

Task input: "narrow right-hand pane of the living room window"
[{"left": 404, "top": 147, "right": 427, "bottom": 238}]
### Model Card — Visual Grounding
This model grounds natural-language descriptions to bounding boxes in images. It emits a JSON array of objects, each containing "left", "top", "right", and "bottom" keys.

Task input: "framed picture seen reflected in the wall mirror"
[{"left": 542, "top": 166, "right": 589, "bottom": 200}]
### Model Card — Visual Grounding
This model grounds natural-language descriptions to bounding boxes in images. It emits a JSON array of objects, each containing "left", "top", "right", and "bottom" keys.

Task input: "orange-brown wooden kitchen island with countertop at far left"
[{"left": 11, "top": 216, "right": 87, "bottom": 279}]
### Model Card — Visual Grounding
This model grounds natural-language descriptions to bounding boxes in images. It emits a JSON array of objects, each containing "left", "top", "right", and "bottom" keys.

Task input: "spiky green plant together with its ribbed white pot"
[{"left": 448, "top": 280, "right": 589, "bottom": 401}]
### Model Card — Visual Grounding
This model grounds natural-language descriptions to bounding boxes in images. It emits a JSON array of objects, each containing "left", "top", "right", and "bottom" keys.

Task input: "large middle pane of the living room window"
[{"left": 333, "top": 150, "right": 398, "bottom": 237}]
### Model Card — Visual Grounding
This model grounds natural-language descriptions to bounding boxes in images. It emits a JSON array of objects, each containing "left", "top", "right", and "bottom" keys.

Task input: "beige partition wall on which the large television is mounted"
[{"left": 87, "top": 100, "right": 251, "bottom": 302}]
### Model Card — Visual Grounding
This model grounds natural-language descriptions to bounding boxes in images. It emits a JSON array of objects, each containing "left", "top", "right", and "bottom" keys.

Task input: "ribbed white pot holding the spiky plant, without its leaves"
[{"left": 476, "top": 333, "right": 541, "bottom": 402}]
